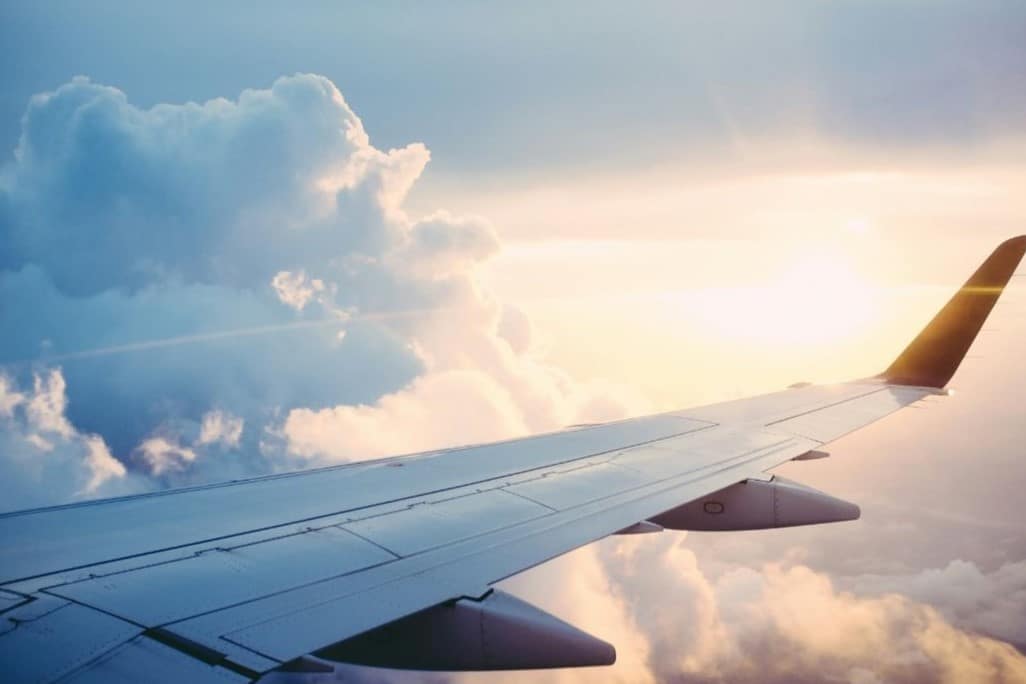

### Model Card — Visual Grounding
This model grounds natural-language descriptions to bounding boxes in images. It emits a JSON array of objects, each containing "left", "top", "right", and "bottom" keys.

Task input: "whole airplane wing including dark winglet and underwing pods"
[{"left": 0, "top": 236, "right": 1026, "bottom": 684}]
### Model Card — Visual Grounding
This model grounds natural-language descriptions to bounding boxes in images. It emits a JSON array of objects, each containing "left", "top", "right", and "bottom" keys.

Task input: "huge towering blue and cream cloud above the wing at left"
[{"left": 0, "top": 75, "right": 644, "bottom": 492}]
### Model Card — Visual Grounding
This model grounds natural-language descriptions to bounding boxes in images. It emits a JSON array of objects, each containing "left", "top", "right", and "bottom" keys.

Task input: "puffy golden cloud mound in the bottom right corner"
[{"left": 717, "top": 566, "right": 1026, "bottom": 683}]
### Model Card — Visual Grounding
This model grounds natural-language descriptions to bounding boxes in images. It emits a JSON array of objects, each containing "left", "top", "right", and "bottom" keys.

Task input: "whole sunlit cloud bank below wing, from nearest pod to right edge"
[{"left": 582, "top": 535, "right": 1026, "bottom": 682}]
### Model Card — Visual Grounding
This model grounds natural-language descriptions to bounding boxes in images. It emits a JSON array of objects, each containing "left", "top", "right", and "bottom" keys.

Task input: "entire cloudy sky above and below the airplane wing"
[{"left": 0, "top": 0, "right": 1026, "bottom": 684}]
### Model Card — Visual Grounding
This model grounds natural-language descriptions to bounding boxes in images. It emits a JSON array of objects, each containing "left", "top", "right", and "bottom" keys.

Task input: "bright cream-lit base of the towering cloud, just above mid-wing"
[{"left": 279, "top": 344, "right": 648, "bottom": 460}]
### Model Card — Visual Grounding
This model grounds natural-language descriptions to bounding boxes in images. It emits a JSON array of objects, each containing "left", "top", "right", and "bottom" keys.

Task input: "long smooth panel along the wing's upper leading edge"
[{"left": 0, "top": 415, "right": 703, "bottom": 585}]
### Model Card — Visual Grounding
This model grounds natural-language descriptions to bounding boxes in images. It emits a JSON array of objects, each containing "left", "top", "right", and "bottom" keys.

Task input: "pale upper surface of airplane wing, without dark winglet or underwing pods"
[{"left": 0, "top": 385, "right": 924, "bottom": 672}]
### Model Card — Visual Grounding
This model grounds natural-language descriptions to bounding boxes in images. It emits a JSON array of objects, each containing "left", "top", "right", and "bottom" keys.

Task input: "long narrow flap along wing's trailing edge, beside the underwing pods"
[{"left": 223, "top": 430, "right": 824, "bottom": 659}]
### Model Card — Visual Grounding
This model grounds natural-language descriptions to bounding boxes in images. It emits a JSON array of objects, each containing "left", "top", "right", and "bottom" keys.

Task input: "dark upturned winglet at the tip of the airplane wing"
[{"left": 879, "top": 235, "right": 1026, "bottom": 389}]
